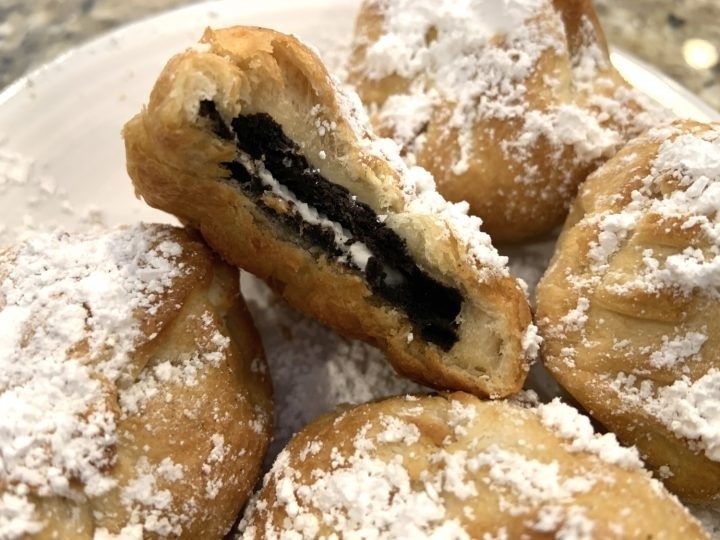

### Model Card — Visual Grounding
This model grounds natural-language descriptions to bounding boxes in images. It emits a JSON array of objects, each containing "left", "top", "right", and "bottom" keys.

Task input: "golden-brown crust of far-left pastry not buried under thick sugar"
[{"left": 0, "top": 225, "right": 272, "bottom": 539}]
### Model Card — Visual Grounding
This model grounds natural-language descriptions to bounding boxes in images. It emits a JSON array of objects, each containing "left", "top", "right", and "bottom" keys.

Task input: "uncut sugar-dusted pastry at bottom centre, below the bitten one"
[{"left": 241, "top": 392, "right": 706, "bottom": 540}]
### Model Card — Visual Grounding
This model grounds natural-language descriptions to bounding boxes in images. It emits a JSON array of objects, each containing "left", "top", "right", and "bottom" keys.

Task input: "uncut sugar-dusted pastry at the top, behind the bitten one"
[{"left": 349, "top": 0, "right": 666, "bottom": 242}]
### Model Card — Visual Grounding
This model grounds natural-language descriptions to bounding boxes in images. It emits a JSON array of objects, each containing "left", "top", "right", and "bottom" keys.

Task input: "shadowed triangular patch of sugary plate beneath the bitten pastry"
[{"left": 242, "top": 274, "right": 429, "bottom": 462}]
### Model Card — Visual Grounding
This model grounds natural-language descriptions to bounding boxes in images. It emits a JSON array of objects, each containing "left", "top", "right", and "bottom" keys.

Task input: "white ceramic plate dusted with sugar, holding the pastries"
[{"left": 0, "top": 4, "right": 720, "bottom": 532}]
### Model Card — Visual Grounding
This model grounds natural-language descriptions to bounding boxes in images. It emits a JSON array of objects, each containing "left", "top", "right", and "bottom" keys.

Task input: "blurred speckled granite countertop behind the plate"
[{"left": 0, "top": 0, "right": 720, "bottom": 110}]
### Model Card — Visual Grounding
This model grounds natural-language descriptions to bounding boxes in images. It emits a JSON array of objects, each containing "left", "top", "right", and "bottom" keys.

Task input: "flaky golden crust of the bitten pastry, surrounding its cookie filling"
[{"left": 124, "top": 27, "right": 531, "bottom": 396}]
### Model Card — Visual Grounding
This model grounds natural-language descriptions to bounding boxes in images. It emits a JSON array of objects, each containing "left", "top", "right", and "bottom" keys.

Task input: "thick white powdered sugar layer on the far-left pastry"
[{"left": 0, "top": 226, "right": 182, "bottom": 538}]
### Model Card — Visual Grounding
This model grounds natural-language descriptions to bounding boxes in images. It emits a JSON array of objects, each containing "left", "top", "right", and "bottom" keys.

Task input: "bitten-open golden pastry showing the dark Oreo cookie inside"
[{"left": 124, "top": 27, "right": 537, "bottom": 396}]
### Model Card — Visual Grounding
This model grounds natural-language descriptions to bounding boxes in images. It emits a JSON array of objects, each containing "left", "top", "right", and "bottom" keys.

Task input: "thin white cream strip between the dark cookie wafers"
[{"left": 238, "top": 152, "right": 380, "bottom": 274}]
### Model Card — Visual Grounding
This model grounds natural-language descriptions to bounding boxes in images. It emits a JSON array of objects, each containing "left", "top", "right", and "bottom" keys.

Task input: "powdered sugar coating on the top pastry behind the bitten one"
[{"left": 354, "top": 0, "right": 667, "bottom": 198}]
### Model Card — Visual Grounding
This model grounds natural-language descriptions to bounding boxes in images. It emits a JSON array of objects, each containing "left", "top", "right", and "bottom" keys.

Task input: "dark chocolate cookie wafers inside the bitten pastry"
[{"left": 200, "top": 101, "right": 462, "bottom": 350}]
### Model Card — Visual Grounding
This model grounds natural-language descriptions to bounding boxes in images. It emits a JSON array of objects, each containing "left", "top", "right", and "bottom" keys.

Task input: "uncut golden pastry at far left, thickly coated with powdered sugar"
[{"left": 0, "top": 225, "right": 271, "bottom": 540}]
